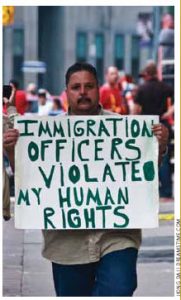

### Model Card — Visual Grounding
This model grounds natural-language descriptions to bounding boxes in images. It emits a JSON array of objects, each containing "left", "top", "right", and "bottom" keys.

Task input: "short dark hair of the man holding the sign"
[{"left": 65, "top": 62, "right": 98, "bottom": 86}]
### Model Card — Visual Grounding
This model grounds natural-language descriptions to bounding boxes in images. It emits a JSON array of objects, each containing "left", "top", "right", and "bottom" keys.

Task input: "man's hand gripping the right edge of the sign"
[{"left": 152, "top": 124, "right": 169, "bottom": 155}]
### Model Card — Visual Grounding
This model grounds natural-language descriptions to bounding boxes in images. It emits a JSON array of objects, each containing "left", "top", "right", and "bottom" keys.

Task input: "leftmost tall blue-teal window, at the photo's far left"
[{"left": 13, "top": 28, "right": 24, "bottom": 88}]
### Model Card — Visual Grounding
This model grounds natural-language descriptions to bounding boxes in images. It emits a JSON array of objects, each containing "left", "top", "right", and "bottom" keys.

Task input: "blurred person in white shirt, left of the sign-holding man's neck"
[{"left": 38, "top": 89, "right": 53, "bottom": 116}]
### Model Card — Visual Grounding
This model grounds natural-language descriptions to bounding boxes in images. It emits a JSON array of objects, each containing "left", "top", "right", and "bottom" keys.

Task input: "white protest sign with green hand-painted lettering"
[{"left": 15, "top": 115, "right": 158, "bottom": 229}]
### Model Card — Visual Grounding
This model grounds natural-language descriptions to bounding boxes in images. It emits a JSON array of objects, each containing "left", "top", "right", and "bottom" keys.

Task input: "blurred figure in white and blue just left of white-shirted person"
[{"left": 26, "top": 83, "right": 38, "bottom": 113}]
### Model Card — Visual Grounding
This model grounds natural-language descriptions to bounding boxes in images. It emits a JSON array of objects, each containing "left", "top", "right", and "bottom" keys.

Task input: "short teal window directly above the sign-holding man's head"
[{"left": 76, "top": 32, "right": 87, "bottom": 62}]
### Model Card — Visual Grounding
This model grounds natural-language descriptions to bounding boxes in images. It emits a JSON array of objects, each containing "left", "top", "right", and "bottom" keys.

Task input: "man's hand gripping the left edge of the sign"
[{"left": 3, "top": 128, "right": 19, "bottom": 153}]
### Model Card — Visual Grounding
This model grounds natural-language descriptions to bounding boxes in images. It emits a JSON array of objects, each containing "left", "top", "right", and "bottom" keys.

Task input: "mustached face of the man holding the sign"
[{"left": 66, "top": 71, "right": 99, "bottom": 115}]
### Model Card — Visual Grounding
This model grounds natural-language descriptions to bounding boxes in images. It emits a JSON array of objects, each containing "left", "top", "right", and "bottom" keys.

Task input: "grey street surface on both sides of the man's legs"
[{"left": 3, "top": 202, "right": 174, "bottom": 297}]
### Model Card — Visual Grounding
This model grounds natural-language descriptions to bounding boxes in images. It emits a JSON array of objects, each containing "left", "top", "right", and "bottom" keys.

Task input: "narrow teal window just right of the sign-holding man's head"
[{"left": 95, "top": 33, "right": 104, "bottom": 83}]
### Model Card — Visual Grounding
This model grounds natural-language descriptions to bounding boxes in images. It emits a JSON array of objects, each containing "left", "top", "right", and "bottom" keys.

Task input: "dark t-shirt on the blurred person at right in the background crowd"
[{"left": 135, "top": 79, "right": 174, "bottom": 116}]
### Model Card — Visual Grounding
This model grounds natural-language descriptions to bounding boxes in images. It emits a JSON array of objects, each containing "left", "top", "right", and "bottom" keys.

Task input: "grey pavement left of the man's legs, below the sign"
[{"left": 3, "top": 219, "right": 55, "bottom": 297}]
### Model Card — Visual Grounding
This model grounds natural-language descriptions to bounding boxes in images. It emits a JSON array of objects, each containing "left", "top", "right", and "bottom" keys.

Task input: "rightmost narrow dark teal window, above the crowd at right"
[{"left": 131, "top": 35, "right": 140, "bottom": 79}]
